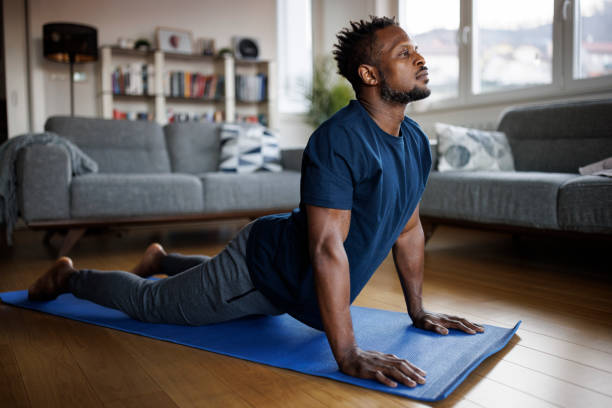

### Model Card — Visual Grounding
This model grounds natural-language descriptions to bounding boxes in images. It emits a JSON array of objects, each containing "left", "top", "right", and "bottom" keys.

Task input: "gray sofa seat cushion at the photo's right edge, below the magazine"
[{"left": 558, "top": 176, "right": 612, "bottom": 234}]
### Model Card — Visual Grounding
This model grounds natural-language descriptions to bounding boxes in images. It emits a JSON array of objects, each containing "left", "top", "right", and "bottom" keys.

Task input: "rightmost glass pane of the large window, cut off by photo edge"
[{"left": 574, "top": 0, "right": 612, "bottom": 78}]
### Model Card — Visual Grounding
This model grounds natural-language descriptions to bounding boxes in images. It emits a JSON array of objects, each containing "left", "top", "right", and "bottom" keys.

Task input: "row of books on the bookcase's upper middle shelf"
[{"left": 164, "top": 71, "right": 223, "bottom": 100}]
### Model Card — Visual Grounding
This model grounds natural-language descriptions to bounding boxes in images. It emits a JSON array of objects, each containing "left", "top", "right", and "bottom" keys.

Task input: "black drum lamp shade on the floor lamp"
[{"left": 43, "top": 23, "right": 98, "bottom": 63}]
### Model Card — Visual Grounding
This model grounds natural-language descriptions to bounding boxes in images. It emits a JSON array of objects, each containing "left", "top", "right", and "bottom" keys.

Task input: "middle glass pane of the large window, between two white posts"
[{"left": 473, "top": 0, "right": 554, "bottom": 93}]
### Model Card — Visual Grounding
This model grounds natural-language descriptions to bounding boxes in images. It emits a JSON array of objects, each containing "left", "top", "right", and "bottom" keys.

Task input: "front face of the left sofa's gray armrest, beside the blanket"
[{"left": 17, "top": 145, "right": 72, "bottom": 222}]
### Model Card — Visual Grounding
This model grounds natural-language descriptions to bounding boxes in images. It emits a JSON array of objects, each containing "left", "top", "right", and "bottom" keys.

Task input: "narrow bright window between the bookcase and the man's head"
[{"left": 277, "top": 0, "right": 312, "bottom": 113}]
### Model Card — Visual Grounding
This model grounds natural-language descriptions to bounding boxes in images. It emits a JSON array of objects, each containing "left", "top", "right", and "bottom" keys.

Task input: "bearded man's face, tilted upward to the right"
[{"left": 376, "top": 26, "right": 431, "bottom": 104}]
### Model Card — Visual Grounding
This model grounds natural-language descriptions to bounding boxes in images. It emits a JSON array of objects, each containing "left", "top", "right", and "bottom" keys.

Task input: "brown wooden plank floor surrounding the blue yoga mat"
[{"left": 0, "top": 220, "right": 612, "bottom": 408}]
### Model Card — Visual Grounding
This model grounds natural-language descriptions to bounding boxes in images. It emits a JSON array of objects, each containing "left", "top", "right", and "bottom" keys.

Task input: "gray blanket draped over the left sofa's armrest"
[{"left": 0, "top": 132, "right": 98, "bottom": 245}]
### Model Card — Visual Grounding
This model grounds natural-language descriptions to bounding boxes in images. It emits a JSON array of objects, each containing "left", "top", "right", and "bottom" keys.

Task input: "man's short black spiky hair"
[{"left": 333, "top": 16, "right": 398, "bottom": 94}]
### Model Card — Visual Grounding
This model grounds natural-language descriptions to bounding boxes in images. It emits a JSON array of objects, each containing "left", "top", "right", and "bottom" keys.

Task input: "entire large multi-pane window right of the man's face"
[{"left": 398, "top": 0, "right": 612, "bottom": 111}]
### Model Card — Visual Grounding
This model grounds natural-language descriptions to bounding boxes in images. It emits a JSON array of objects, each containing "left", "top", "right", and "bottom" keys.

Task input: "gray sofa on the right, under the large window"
[{"left": 420, "top": 100, "right": 612, "bottom": 238}]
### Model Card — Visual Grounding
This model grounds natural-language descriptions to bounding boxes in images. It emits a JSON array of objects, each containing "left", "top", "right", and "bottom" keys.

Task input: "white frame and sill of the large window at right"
[{"left": 398, "top": 0, "right": 612, "bottom": 113}]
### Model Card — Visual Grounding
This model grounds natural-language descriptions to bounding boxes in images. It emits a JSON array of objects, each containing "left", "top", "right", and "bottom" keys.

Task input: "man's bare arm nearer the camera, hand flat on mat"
[{"left": 306, "top": 205, "right": 425, "bottom": 387}]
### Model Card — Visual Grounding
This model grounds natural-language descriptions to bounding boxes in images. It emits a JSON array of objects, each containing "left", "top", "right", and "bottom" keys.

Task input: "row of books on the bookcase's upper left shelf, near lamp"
[{"left": 111, "top": 64, "right": 155, "bottom": 95}]
